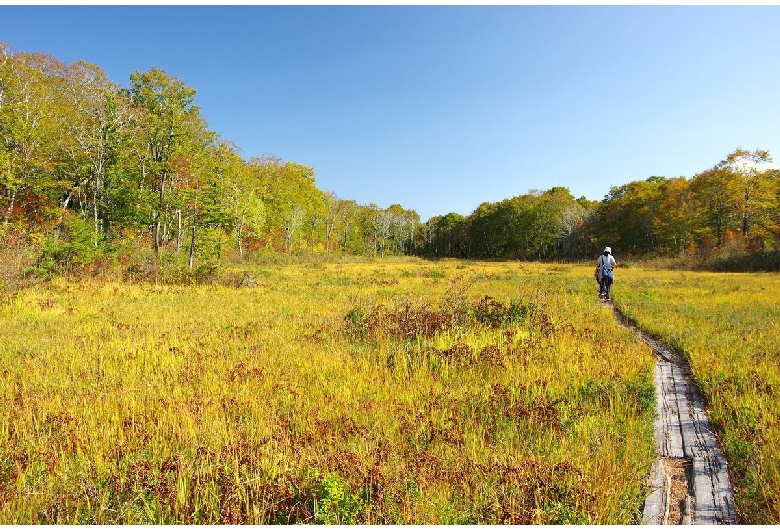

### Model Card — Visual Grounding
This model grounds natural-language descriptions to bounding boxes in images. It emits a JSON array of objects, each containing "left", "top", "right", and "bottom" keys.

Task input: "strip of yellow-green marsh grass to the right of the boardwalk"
[{"left": 615, "top": 268, "right": 780, "bottom": 524}]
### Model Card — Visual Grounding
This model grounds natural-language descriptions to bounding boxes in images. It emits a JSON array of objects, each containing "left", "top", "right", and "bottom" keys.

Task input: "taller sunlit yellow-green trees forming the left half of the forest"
[{"left": 0, "top": 43, "right": 420, "bottom": 266}]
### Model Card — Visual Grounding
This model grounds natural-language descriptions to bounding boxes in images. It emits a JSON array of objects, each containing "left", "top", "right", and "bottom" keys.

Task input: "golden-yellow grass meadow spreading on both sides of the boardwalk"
[{"left": 0, "top": 259, "right": 780, "bottom": 524}]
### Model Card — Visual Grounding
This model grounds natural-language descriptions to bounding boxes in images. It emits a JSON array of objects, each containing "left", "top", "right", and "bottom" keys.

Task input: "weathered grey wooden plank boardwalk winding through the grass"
[{"left": 614, "top": 309, "right": 737, "bottom": 524}]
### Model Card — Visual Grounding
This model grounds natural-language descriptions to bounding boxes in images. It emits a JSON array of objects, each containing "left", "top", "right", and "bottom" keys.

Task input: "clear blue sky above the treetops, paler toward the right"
[{"left": 0, "top": 5, "right": 780, "bottom": 221}]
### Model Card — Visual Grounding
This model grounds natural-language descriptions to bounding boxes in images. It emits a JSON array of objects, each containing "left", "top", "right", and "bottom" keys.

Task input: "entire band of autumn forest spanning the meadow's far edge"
[{"left": 0, "top": 42, "right": 780, "bottom": 273}]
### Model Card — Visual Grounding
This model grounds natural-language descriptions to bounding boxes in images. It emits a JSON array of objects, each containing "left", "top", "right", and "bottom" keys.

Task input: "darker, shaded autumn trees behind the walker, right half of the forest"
[{"left": 427, "top": 148, "right": 780, "bottom": 270}]
